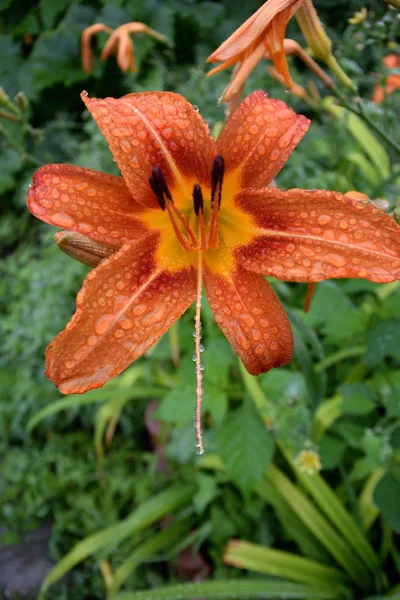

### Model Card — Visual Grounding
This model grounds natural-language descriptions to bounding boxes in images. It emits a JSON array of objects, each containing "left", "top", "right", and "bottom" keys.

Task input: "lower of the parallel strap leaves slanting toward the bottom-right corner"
[{"left": 267, "top": 465, "right": 371, "bottom": 589}]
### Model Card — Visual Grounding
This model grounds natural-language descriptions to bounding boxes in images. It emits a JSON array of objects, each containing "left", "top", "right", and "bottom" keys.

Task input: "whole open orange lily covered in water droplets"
[{"left": 28, "top": 91, "right": 400, "bottom": 450}]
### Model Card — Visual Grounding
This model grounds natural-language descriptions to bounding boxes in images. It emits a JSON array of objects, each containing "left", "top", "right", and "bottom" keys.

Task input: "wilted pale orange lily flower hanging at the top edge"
[{"left": 207, "top": 0, "right": 305, "bottom": 102}]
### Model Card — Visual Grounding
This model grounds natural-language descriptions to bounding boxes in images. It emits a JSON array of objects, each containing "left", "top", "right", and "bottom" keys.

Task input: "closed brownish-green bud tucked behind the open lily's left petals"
[{"left": 54, "top": 231, "right": 120, "bottom": 267}]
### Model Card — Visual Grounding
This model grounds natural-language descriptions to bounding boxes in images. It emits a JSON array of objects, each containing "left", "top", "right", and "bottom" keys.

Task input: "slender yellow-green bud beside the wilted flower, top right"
[{"left": 296, "top": 0, "right": 356, "bottom": 90}]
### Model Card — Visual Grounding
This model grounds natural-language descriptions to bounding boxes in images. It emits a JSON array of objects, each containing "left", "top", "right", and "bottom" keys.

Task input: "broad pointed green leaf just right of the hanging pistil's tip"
[{"left": 217, "top": 402, "right": 274, "bottom": 495}]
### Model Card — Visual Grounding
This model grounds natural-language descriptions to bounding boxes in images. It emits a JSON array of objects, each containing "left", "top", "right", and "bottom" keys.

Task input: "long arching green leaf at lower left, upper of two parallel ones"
[{"left": 39, "top": 486, "right": 193, "bottom": 600}]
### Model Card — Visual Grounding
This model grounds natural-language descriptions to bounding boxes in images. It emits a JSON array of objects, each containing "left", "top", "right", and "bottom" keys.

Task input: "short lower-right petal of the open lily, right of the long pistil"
[{"left": 204, "top": 265, "right": 293, "bottom": 375}]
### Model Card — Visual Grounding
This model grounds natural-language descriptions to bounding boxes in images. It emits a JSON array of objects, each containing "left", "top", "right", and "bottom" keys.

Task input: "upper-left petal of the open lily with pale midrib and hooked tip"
[{"left": 81, "top": 92, "right": 215, "bottom": 207}]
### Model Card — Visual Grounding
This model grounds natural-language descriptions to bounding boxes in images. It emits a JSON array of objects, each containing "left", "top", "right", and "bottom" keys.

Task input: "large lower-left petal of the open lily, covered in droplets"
[{"left": 46, "top": 232, "right": 196, "bottom": 394}]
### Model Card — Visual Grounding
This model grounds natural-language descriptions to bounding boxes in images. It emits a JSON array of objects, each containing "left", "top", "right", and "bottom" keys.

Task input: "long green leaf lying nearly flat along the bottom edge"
[{"left": 116, "top": 579, "right": 346, "bottom": 600}]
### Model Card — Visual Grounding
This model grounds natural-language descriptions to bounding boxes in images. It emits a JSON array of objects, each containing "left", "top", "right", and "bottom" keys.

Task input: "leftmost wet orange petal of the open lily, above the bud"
[{"left": 27, "top": 165, "right": 146, "bottom": 244}]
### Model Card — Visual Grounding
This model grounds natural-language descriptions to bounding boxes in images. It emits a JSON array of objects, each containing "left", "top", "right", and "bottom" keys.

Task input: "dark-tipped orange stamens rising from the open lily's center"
[{"left": 149, "top": 154, "right": 225, "bottom": 252}]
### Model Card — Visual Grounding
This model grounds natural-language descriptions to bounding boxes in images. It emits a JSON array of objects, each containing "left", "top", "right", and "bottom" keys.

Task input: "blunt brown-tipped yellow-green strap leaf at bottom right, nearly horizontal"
[{"left": 224, "top": 540, "right": 346, "bottom": 585}]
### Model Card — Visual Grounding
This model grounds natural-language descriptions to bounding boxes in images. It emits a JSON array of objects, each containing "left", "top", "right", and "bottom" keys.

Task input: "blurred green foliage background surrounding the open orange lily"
[{"left": 0, "top": 0, "right": 400, "bottom": 599}]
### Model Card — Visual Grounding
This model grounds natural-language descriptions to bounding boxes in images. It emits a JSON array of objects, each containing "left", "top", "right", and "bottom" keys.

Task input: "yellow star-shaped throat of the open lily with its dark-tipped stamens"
[{"left": 142, "top": 155, "right": 252, "bottom": 271}]
